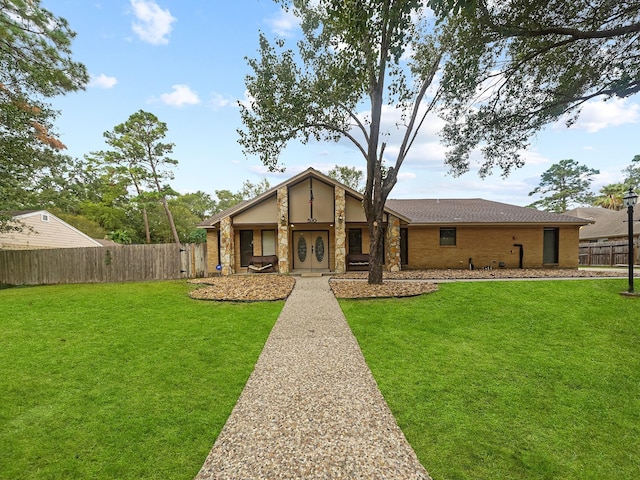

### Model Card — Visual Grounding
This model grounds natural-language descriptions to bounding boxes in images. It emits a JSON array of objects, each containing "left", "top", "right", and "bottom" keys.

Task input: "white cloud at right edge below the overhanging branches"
[{"left": 554, "top": 98, "right": 640, "bottom": 133}]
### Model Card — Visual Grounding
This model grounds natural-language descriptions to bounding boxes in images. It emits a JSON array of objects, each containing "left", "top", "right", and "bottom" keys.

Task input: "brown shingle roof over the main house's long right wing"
[{"left": 386, "top": 198, "right": 589, "bottom": 225}]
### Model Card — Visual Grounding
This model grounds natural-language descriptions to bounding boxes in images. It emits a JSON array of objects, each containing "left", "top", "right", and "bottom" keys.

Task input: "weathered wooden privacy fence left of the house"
[{"left": 0, "top": 243, "right": 207, "bottom": 285}]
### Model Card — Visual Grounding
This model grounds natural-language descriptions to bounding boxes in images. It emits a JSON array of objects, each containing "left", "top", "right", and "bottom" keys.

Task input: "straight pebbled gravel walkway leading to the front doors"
[{"left": 196, "top": 277, "right": 430, "bottom": 480}]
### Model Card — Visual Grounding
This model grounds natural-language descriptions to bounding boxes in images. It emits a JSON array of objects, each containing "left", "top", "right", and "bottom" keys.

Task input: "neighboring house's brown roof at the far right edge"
[{"left": 567, "top": 207, "right": 640, "bottom": 240}]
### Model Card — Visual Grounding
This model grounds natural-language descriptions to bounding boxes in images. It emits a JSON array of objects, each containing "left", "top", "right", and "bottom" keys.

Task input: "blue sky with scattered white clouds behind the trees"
[{"left": 41, "top": 0, "right": 640, "bottom": 205}]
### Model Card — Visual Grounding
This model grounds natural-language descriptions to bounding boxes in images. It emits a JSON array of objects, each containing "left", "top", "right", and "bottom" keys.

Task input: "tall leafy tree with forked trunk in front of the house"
[{"left": 239, "top": 0, "right": 443, "bottom": 283}]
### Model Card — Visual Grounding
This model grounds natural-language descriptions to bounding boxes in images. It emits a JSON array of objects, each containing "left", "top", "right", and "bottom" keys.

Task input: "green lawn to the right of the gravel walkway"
[{"left": 340, "top": 280, "right": 640, "bottom": 480}]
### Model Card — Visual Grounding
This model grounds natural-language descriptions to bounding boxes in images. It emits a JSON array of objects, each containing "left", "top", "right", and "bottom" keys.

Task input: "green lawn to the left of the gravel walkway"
[{"left": 0, "top": 282, "right": 283, "bottom": 479}]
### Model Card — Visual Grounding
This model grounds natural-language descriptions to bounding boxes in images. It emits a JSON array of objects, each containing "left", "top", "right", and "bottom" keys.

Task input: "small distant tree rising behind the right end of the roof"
[{"left": 529, "top": 159, "right": 600, "bottom": 213}]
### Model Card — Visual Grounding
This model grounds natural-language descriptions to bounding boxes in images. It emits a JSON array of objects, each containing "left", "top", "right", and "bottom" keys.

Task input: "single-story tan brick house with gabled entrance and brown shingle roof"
[{"left": 199, "top": 168, "right": 589, "bottom": 274}]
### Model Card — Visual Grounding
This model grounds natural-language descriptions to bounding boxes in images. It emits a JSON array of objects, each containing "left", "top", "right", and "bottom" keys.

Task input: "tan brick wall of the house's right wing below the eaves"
[{"left": 408, "top": 225, "right": 579, "bottom": 269}]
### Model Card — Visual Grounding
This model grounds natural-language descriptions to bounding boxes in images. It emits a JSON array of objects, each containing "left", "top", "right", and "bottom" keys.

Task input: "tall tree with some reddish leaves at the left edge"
[{"left": 0, "top": 0, "right": 88, "bottom": 231}]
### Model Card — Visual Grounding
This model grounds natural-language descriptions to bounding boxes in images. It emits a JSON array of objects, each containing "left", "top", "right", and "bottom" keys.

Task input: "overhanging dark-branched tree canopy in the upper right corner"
[{"left": 436, "top": 0, "right": 640, "bottom": 175}]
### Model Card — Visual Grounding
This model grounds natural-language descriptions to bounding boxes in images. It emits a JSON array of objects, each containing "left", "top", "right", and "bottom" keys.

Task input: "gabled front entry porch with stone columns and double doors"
[{"left": 200, "top": 169, "right": 400, "bottom": 275}]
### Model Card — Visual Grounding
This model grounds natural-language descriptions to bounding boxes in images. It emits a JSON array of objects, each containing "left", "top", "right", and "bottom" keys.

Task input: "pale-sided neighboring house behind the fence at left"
[{"left": 0, "top": 210, "right": 102, "bottom": 250}]
